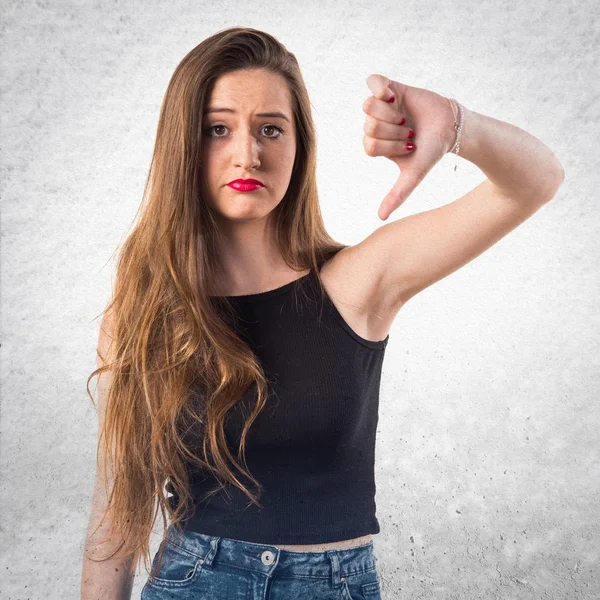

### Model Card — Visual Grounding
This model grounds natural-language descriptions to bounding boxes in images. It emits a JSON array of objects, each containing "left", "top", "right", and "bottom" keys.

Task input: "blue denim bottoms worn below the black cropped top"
[{"left": 141, "top": 525, "right": 381, "bottom": 600}]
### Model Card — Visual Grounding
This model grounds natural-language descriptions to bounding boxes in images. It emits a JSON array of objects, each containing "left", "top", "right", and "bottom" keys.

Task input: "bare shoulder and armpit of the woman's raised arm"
[{"left": 321, "top": 244, "right": 399, "bottom": 341}]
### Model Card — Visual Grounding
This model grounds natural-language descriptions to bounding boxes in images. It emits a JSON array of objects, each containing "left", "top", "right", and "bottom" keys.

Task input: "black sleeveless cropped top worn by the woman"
[{"left": 167, "top": 262, "right": 389, "bottom": 544}]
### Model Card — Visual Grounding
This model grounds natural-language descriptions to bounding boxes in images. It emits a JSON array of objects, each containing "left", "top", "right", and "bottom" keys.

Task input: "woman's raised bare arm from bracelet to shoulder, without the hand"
[{"left": 346, "top": 97, "right": 565, "bottom": 317}]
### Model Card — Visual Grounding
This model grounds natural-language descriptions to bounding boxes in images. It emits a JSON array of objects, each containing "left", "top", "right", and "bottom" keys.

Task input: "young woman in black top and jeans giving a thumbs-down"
[{"left": 82, "top": 27, "right": 564, "bottom": 600}]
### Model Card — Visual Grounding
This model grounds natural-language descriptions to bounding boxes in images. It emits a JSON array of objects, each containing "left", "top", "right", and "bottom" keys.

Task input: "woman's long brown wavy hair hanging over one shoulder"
[{"left": 87, "top": 27, "right": 346, "bottom": 575}]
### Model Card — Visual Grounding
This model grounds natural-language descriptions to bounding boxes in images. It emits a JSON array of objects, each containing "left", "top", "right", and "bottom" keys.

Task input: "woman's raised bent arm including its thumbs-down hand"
[{"left": 347, "top": 76, "right": 564, "bottom": 313}]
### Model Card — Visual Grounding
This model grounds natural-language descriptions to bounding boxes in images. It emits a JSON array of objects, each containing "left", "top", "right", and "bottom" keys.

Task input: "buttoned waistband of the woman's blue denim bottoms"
[{"left": 166, "top": 525, "right": 376, "bottom": 583}]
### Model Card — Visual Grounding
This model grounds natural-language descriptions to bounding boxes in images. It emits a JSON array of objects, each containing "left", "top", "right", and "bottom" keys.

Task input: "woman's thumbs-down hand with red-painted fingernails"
[{"left": 363, "top": 75, "right": 458, "bottom": 221}]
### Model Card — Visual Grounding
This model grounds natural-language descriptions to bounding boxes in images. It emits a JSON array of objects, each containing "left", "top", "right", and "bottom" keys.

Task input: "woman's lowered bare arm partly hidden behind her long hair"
[{"left": 81, "top": 316, "right": 134, "bottom": 600}]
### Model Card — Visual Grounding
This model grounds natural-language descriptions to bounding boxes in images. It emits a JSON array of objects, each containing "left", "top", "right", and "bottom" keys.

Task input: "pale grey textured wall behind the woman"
[{"left": 0, "top": 0, "right": 600, "bottom": 600}]
